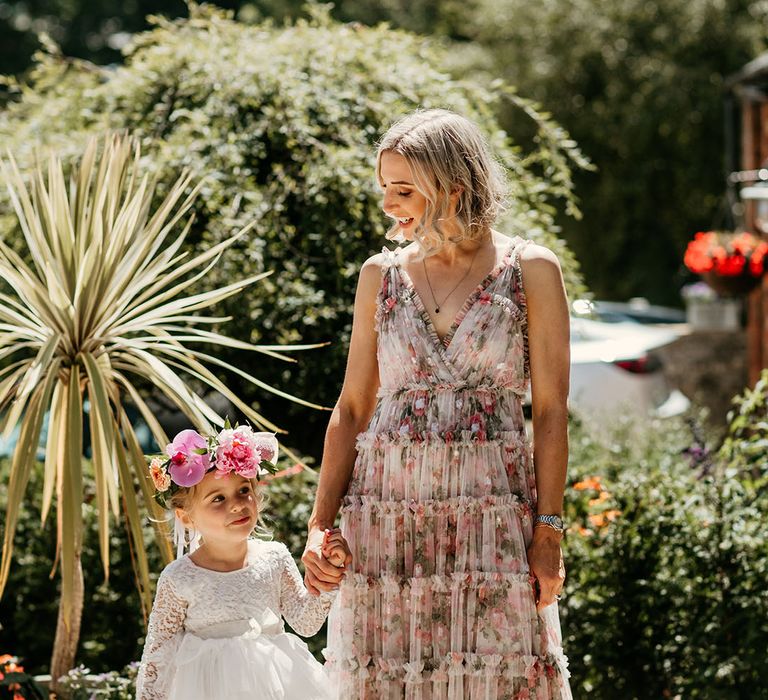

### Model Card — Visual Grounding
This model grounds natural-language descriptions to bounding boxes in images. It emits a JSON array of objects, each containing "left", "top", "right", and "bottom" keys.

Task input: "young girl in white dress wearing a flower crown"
[{"left": 136, "top": 427, "right": 349, "bottom": 700}]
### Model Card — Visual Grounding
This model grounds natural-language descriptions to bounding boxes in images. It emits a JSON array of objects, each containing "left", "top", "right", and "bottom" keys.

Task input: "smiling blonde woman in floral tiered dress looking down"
[{"left": 303, "top": 110, "right": 571, "bottom": 700}]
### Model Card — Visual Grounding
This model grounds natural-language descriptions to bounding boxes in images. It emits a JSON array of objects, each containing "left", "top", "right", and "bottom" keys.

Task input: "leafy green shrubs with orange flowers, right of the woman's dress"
[{"left": 563, "top": 408, "right": 768, "bottom": 700}]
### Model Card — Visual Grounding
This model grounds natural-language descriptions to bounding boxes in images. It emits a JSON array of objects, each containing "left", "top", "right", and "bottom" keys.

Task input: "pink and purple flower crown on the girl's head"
[{"left": 149, "top": 421, "right": 277, "bottom": 508}]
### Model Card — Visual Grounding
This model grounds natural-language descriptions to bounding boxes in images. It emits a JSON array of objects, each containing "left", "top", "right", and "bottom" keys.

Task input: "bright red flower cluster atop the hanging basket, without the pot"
[{"left": 684, "top": 231, "right": 768, "bottom": 277}]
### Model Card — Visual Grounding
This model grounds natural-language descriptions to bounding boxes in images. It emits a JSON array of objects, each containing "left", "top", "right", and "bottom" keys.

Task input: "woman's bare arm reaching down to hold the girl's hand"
[{"left": 302, "top": 255, "right": 383, "bottom": 594}]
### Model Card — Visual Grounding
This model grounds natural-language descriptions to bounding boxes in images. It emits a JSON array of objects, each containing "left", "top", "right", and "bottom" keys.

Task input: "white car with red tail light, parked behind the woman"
[{"left": 526, "top": 316, "right": 690, "bottom": 419}]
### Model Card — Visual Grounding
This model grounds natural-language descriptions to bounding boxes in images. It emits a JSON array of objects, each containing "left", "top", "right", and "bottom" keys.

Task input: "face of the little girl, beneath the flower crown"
[{"left": 177, "top": 471, "right": 258, "bottom": 544}]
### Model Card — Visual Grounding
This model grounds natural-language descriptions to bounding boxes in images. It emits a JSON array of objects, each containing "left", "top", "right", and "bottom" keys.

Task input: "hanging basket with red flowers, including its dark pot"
[{"left": 684, "top": 231, "right": 768, "bottom": 296}]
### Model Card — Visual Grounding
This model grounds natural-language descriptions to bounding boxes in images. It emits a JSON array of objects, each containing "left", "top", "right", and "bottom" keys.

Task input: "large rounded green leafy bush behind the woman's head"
[{"left": 0, "top": 5, "right": 583, "bottom": 456}]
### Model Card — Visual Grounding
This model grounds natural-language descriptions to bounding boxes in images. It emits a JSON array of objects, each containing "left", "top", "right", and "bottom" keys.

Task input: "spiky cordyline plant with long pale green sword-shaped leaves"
[{"left": 0, "top": 135, "right": 320, "bottom": 626}]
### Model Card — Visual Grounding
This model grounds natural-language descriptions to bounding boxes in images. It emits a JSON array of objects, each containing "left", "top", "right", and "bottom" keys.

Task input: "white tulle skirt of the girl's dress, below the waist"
[{"left": 169, "top": 632, "right": 335, "bottom": 700}]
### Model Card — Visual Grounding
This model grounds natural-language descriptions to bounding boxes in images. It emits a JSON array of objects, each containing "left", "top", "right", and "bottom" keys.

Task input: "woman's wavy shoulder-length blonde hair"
[{"left": 376, "top": 109, "right": 507, "bottom": 255}]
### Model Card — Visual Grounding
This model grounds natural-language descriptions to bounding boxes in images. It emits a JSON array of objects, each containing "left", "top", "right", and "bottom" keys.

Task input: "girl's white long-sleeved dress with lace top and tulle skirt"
[{"left": 136, "top": 540, "right": 335, "bottom": 700}]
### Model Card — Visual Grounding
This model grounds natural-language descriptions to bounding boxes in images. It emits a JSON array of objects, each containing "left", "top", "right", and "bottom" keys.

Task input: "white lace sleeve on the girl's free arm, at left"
[{"left": 136, "top": 572, "right": 187, "bottom": 700}]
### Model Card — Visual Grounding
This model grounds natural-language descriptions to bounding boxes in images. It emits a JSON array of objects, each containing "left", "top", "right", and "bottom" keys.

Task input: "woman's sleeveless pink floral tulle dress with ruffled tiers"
[{"left": 325, "top": 237, "right": 571, "bottom": 700}]
